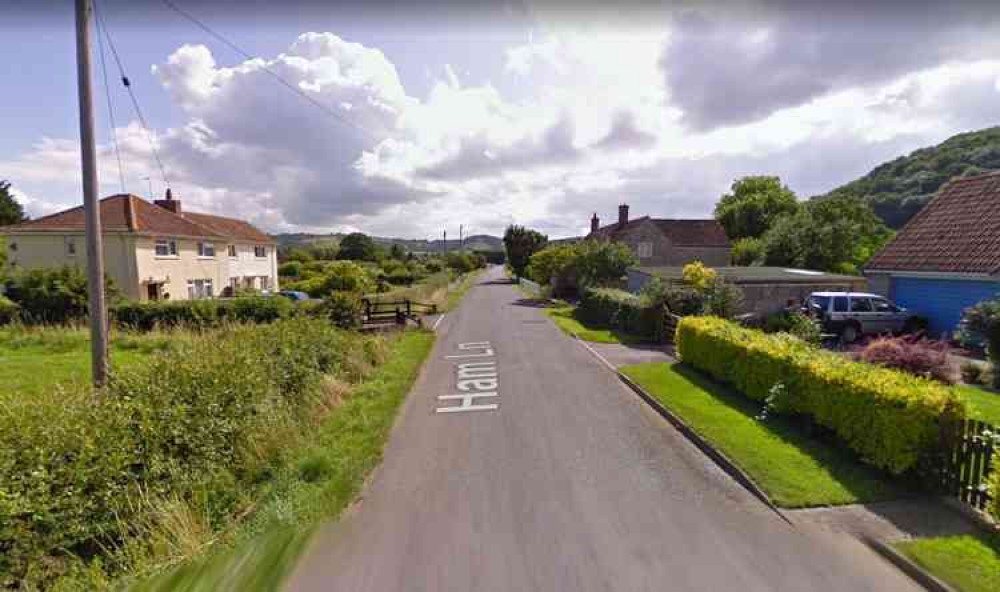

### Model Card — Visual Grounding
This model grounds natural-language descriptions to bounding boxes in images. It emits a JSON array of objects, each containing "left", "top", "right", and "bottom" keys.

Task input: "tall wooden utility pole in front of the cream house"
[{"left": 76, "top": 0, "right": 108, "bottom": 386}]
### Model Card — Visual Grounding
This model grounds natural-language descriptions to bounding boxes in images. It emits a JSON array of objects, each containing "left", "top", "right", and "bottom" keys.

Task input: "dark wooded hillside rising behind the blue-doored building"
[{"left": 821, "top": 127, "right": 1000, "bottom": 228}]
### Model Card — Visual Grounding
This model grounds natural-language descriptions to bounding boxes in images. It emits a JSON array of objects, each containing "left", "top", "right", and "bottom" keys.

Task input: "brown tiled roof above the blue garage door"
[{"left": 865, "top": 172, "right": 1000, "bottom": 274}]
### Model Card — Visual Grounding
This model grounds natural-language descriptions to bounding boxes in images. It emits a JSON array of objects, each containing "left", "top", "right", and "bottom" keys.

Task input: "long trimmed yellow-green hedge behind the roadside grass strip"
[{"left": 676, "top": 317, "right": 966, "bottom": 473}]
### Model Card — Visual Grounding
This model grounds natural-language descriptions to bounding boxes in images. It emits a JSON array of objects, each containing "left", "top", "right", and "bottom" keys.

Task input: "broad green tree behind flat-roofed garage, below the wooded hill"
[{"left": 763, "top": 193, "right": 893, "bottom": 273}]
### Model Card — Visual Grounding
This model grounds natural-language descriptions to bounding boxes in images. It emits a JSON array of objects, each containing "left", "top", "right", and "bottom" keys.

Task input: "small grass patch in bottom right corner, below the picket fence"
[{"left": 895, "top": 534, "right": 1000, "bottom": 592}]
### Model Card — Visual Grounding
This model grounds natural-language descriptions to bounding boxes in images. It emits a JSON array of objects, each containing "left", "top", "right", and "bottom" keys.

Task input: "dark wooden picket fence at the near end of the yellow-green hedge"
[{"left": 934, "top": 419, "right": 1000, "bottom": 510}]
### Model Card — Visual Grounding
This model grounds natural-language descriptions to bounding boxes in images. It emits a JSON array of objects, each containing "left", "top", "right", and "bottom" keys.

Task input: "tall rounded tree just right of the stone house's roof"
[{"left": 715, "top": 176, "right": 799, "bottom": 240}]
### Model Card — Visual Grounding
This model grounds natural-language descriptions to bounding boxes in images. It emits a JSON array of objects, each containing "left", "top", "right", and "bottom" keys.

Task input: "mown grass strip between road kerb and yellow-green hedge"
[{"left": 621, "top": 364, "right": 903, "bottom": 508}]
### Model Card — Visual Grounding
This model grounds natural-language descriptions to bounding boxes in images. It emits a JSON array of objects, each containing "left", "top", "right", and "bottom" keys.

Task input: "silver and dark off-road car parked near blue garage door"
[{"left": 803, "top": 292, "right": 920, "bottom": 343}]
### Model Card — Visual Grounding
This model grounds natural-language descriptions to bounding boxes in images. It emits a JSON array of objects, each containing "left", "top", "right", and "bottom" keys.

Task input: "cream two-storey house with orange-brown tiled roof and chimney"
[{"left": 0, "top": 189, "right": 278, "bottom": 300}]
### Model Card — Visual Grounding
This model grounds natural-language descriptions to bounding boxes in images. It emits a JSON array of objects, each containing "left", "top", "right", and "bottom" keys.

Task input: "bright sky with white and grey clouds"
[{"left": 0, "top": 0, "right": 1000, "bottom": 239}]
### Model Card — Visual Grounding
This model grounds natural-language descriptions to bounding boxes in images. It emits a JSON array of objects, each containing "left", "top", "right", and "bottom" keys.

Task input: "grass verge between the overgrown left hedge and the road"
[{"left": 133, "top": 331, "right": 434, "bottom": 592}]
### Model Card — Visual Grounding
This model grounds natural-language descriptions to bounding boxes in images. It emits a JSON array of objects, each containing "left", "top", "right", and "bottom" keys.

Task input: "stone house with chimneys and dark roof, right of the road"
[{"left": 587, "top": 204, "right": 731, "bottom": 267}]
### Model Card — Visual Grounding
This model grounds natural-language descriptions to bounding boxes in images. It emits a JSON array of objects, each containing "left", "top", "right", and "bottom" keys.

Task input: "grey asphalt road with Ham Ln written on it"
[{"left": 289, "top": 270, "right": 919, "bottom": 592}]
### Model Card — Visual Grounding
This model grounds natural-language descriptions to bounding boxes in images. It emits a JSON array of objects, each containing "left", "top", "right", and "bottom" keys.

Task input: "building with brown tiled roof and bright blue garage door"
[{"left": 864, "top": 172, "right": 1000, "bottom": 335}]
